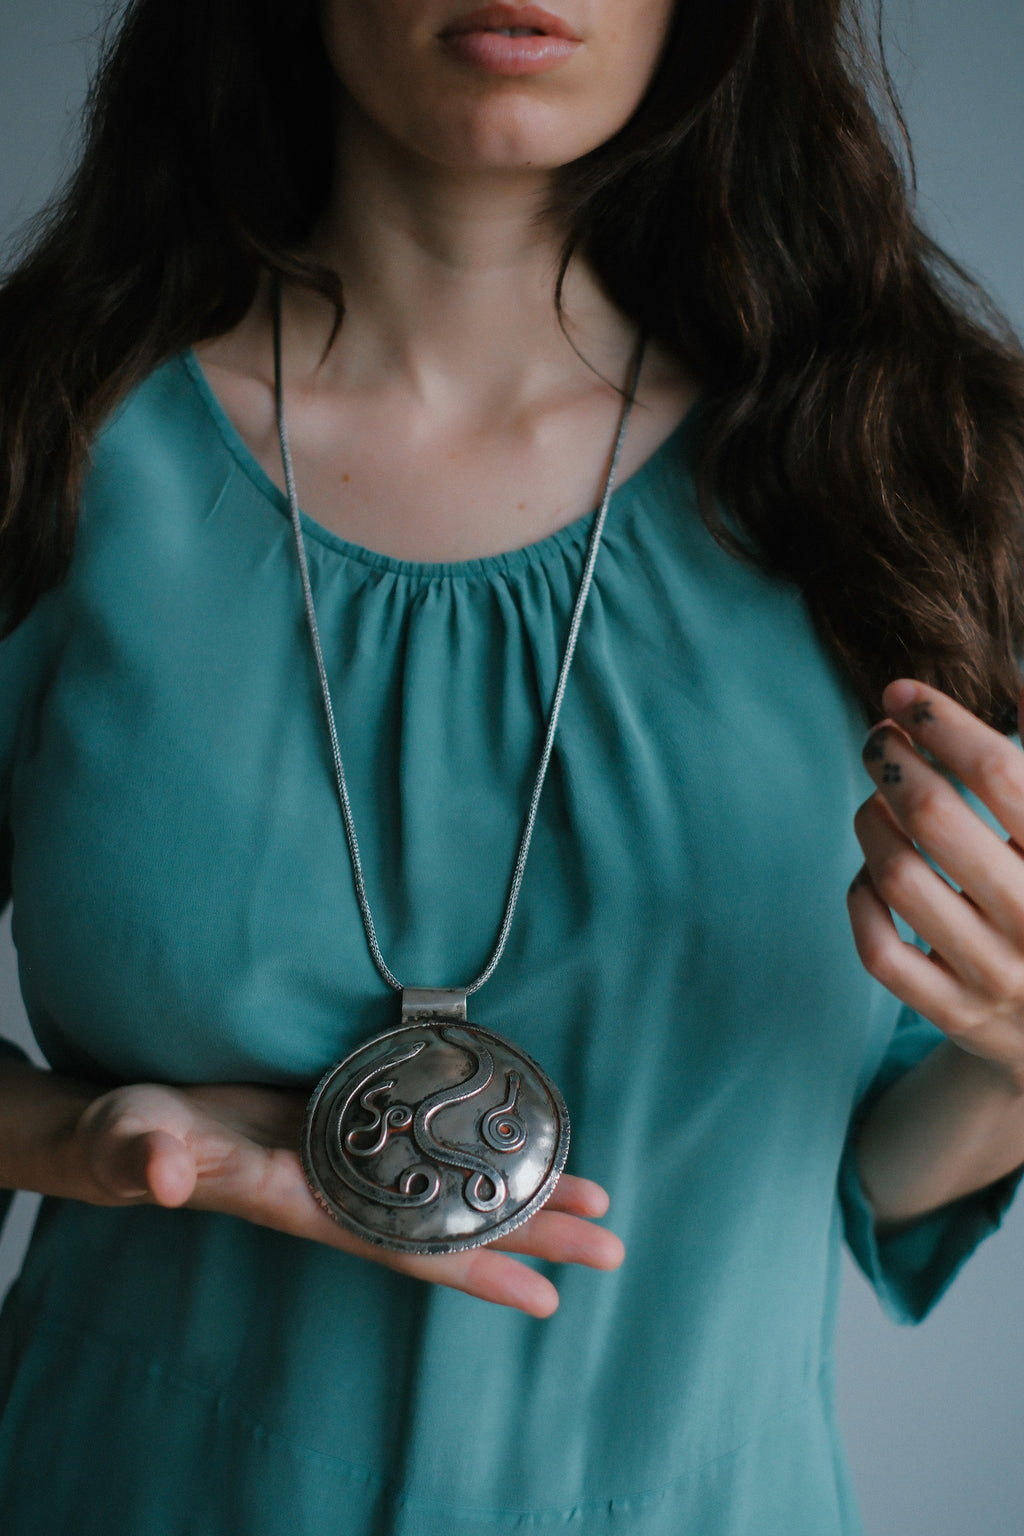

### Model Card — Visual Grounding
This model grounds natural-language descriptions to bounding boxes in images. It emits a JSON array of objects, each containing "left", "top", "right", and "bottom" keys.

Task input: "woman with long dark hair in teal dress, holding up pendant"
[{"left": 0, "top": 0, "right": 1024, "bottom": 1536}]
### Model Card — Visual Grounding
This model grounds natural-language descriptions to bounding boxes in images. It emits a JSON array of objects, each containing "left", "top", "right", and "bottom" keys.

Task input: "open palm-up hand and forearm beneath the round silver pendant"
[{"left": 0, "top": 1063, "right": 623, "bottom": 1318}]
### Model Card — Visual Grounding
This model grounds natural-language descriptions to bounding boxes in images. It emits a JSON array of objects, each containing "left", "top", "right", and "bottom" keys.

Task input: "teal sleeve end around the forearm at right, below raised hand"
[{"left": 840, "top": 1008, "right": 1021, "bottom": 1322}]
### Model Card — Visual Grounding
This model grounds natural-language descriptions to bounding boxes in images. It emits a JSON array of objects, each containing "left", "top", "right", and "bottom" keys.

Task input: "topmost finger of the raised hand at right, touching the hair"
[{"left": 883, "top": 677, "right": 1024, "bottom": 845}]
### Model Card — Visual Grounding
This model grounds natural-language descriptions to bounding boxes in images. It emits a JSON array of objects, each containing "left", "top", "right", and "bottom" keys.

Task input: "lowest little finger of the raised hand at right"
[{"left": 846, "top": 866, "right": 976, "bottom": 1034}]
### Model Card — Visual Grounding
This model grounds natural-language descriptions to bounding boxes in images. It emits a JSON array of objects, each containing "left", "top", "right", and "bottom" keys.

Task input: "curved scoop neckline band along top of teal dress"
[{"left": 181, "top": 347, "right": 700, "bottom": 581}]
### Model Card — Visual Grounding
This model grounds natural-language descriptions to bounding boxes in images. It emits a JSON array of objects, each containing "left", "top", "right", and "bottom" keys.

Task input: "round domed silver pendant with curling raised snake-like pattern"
[{"left": 301, "top": 1020, "right": 570, "bottom": 1253}]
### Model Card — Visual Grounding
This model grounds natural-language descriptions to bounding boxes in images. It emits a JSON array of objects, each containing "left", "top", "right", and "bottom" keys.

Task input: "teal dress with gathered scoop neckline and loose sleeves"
[{"left": 0, "top": 356, "right": 1012, "bottom": 1536}]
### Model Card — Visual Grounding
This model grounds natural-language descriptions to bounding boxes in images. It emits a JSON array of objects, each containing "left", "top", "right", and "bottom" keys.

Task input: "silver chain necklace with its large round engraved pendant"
[{"left": 280, "top": 292, "right": 643, "bottom": 1253}]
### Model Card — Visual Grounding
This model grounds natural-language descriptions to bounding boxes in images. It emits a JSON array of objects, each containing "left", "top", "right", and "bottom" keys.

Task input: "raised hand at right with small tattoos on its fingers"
[{"left": 849, "top": 679, "right": 1024, "bottom": 1094}]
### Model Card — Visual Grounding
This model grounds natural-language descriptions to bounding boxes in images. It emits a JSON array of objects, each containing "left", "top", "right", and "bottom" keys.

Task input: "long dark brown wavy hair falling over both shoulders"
[{"left": 0, "top": 0, "right": 1024, "bottom": 728}]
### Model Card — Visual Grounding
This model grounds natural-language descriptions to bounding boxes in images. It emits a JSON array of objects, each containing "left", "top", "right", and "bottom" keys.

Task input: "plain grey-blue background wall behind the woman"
[{"left": 0, "top": 0, "right": 1024, "bottom": 1536}]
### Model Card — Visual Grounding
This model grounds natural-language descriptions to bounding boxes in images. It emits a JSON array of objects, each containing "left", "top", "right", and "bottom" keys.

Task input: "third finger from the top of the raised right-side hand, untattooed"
[{"left": 854, "top": 792, "right": 1024, "bottom": 997}]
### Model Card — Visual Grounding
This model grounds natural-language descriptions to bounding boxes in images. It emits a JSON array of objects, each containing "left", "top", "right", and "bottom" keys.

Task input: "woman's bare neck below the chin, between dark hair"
[{"left": 290, "top": 105, "right": 634, "bottom": 409}]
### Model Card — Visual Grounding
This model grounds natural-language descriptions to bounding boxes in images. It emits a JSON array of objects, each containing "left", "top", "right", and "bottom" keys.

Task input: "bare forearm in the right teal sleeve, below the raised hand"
[{"left": 857, "top": 1043, "right": 1024, "bottom": 1226}]
